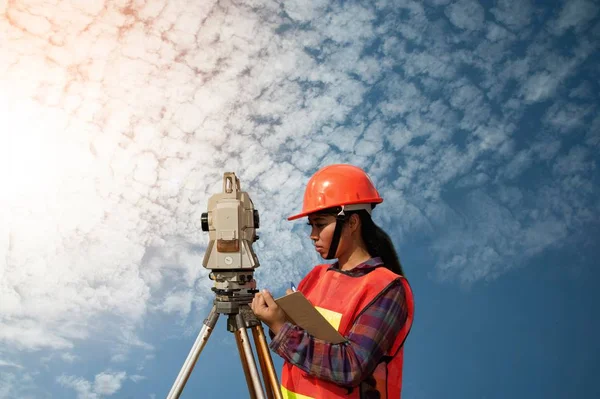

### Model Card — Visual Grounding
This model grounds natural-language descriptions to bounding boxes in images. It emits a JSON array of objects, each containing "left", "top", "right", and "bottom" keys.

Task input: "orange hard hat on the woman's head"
[{"left": 288, "top": 164, "right": 383, "bottom": 220}]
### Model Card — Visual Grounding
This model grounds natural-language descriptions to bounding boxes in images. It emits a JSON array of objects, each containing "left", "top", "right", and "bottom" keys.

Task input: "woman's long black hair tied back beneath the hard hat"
[{"left": 315, "top": 207, "right": 404, "bottom": 276}]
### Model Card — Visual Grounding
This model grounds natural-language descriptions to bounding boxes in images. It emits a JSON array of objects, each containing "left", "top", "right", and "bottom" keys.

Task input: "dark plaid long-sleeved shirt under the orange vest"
[{"left": 269, "top": 258, "right": 407, "bottom": 387}]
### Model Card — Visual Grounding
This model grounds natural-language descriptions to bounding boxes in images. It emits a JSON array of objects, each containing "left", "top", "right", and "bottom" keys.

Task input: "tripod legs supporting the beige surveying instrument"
[{"left": 167, "top": 288, "right": 282, "bottom": 399}]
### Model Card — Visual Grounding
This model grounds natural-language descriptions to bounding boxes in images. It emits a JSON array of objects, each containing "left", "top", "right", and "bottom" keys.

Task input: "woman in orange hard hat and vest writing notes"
[{"left": 252, "top": 165, "right": 414, "bottom": 399}]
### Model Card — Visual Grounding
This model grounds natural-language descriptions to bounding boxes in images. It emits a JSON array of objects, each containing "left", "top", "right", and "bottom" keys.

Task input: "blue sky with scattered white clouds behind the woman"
[{"left": 0, "top": 0, "right": 600, "bottom": 399}]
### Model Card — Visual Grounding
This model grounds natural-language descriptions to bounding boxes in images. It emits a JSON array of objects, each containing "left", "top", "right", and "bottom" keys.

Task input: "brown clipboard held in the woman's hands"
[{"left": 275, "top": 291, "right": 346, "bottom": 344}]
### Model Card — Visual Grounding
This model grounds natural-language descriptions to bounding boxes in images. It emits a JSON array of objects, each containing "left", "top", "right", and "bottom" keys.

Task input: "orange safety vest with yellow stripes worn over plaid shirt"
[{"left": 281, "top": 264, "right": 414, "bottom": 399}]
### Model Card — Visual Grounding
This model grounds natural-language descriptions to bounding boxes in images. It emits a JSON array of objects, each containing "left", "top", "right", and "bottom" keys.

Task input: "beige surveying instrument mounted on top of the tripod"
[{"left": 201, "top": 172, "right": 260, "bottom": 313}]
